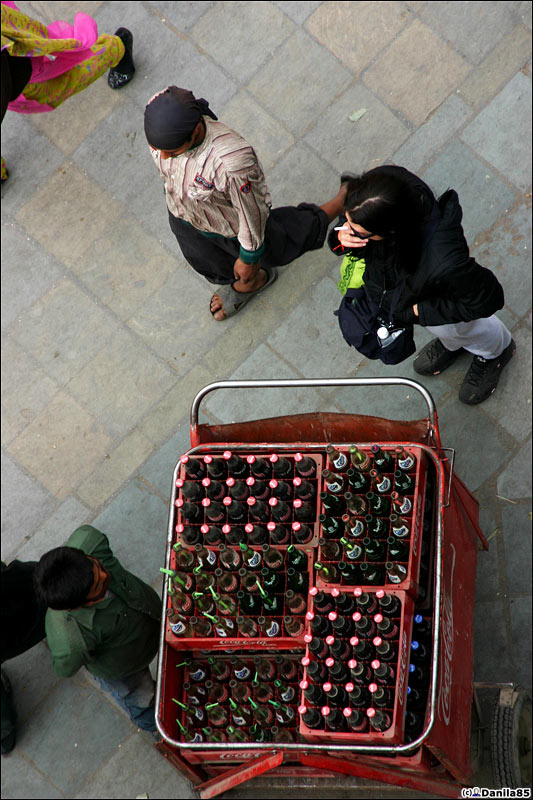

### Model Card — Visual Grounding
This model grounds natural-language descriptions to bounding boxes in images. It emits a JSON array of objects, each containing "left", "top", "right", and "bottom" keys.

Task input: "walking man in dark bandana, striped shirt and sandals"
[{"left": 144, "top": 86, "right": 346, "bottom": 321}]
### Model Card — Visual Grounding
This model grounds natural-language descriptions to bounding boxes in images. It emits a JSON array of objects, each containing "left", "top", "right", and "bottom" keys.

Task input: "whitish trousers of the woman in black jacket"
[{"left": 426, "top": 314, "right": 512, "bottom": 359}]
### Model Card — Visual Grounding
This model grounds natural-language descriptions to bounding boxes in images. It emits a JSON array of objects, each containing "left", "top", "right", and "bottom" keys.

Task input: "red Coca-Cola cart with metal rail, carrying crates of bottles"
[{"left": 152, "top": 378, "right": 531, "bottom": 798}]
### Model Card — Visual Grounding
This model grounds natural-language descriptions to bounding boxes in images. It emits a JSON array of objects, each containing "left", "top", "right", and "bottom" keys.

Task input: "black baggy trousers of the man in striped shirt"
[{"left": 168, "top": 203, "right": 329, "bottom": 285}]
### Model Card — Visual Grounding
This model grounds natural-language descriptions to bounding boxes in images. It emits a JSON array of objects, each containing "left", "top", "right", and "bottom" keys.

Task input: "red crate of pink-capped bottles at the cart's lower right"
[{"left": 300, "top": 587, "right": 414, "bottom": 744}]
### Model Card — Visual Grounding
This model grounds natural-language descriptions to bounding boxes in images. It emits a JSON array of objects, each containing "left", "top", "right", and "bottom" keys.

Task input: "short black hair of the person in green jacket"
[{"left": 33, "top": 547, "right": 94, "bottom": 611}]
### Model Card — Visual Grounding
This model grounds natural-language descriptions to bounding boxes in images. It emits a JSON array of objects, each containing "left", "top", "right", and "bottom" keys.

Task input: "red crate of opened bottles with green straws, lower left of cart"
[{"left": 160, "top": 645, "right": 303, "bottom": 764}]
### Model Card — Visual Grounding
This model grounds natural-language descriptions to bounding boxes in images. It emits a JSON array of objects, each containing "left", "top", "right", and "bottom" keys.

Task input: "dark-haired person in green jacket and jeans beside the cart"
[{"left": 34, "top": 525, "right": 161, "bottom": 732}]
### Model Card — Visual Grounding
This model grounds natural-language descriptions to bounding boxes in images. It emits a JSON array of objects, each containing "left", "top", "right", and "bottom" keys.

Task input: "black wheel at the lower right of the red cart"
[{"left": 491, "top": 687, "right": 531, "bottom": 789}]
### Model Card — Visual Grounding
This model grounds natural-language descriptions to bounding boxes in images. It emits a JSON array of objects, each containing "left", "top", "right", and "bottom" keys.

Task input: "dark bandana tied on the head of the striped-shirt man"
[{"left": 144, "top": 86, "right": 218, "bottom": 150}]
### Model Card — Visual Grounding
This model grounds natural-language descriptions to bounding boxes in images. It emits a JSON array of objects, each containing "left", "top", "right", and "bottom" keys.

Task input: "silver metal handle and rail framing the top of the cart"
[{"left": 155, "top": 378, "right": 444, "bottom": 755}]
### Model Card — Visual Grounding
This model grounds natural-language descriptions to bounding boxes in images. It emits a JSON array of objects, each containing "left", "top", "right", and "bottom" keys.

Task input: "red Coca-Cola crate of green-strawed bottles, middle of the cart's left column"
[{"left": 165, "top": 547, "right": 314, "bottom": 650}]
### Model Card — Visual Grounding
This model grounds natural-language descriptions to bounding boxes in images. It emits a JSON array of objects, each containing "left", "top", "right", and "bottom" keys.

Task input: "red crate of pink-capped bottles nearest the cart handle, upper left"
[{"left": 172, "top": 448, "right": 324, "bottom": 547}]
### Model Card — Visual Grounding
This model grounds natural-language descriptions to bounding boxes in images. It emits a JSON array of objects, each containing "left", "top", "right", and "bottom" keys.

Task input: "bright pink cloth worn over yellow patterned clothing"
[{"left": 2, "top": 0, "right": 105, "bottom": 114}]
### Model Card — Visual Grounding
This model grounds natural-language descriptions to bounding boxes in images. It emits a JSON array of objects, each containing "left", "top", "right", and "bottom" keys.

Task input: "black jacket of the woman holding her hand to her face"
[{"left": 328, "top": 166, "right": 504, "bottom": 325}]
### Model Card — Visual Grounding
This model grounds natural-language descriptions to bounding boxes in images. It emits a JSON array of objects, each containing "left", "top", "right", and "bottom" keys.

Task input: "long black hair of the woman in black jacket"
[{"left": 344, "top": 169, "right": 424, "bottom": 272}]
